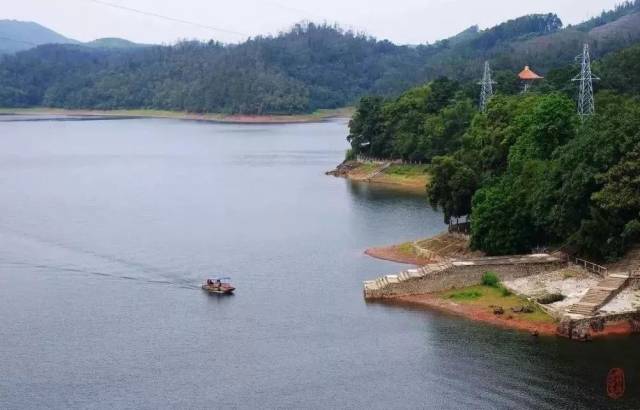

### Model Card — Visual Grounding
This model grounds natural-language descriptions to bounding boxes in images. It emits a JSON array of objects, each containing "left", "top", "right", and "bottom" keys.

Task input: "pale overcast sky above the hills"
[{"left": 5, "top": 0, "right": 621, "bottom": 44}]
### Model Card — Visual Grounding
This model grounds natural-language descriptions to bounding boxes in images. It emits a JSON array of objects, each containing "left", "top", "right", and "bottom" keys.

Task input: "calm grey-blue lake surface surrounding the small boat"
[{"left": 0, "top": 117, "right": 640, "bottom": 409}]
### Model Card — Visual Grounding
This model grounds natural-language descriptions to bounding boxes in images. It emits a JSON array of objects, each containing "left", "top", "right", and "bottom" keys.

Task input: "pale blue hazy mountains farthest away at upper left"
[{"left": 0, "top": 20, "right": 142, "bottom": 54}]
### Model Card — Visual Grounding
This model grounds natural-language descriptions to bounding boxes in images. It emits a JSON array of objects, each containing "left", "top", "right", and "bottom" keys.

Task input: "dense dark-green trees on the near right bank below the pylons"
[{"left": 348, "top": 40, "right": 640, "bottom": 260}]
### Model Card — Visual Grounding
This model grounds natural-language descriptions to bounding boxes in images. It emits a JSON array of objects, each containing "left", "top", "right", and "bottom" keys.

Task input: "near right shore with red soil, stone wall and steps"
[{"left": 364, "top": 234, "right": 640, "bottom": 341}]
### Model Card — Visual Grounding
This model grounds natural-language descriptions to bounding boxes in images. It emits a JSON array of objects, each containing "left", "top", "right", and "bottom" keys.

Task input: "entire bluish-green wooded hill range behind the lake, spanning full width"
[{"left": 0, "top": 2, "right": 640, "bottom": 114}]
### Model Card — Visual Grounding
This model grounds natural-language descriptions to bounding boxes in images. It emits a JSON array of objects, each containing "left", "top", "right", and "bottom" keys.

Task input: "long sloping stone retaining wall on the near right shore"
[{"left": 365, "top": 255, "right": 567, "bottom": 299}]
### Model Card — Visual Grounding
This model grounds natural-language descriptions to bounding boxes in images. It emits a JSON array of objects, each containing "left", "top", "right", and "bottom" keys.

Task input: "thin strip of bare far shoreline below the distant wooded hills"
[{"left": 0, "top": 107, "right": 353, "bottom": 125}]
